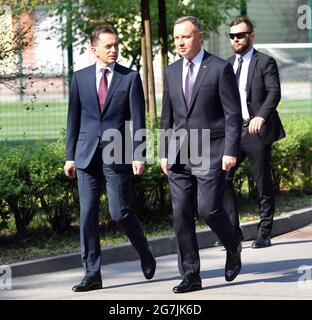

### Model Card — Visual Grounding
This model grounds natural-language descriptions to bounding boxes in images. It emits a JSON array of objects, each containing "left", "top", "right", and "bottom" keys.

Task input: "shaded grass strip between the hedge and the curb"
[{"left": 0, "top": 192, "right": 312, "bottom": 264}]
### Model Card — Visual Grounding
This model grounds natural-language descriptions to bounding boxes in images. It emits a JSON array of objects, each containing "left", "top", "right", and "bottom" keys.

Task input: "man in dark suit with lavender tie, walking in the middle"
[{"left": 161, "top": 16, "right": 241, "bottom": 293}]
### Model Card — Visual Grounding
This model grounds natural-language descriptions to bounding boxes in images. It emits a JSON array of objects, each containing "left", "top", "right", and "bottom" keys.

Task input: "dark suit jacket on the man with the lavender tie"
[{"left": 161, "top": 51, "right": 242, "bottom": 168}]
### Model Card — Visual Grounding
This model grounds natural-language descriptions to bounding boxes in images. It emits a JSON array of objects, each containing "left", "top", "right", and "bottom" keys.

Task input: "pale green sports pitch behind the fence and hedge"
[{"left": 0, "top": 100, "right": 312, "bottom": 141}]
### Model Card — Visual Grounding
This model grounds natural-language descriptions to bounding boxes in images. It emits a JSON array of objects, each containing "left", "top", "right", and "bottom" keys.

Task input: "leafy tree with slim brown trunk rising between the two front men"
[{"left": 50, "top": 0, "right": 241, "bottom": 125}]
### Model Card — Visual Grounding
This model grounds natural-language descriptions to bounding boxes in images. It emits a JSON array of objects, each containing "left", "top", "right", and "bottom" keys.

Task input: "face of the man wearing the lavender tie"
[{"left": 173, "top": 21, "right": 203, "bottom": 60}]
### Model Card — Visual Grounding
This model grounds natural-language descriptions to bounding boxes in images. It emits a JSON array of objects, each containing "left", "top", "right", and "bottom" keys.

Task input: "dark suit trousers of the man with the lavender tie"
[{"left": 168, "top": 164, "right": 239, "bottom": 276}]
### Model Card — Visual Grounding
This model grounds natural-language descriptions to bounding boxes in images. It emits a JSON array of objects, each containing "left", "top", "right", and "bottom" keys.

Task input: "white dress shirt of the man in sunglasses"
[{"left": 233, "top": 48, "right": 254, "bottom": 120}]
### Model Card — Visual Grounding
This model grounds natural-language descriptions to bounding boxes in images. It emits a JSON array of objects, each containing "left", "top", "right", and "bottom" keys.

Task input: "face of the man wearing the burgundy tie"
[{"left": 91, "top": 33, "right": 119, "bottom": 66}]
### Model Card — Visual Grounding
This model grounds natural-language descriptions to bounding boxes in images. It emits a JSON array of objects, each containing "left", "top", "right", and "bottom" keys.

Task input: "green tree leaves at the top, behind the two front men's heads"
[{"left": 50, "top": 0, "right": 240, "bottom": 69}]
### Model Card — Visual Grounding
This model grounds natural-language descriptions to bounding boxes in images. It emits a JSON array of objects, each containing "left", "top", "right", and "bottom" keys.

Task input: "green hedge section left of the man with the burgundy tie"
[{"left": 0, "top": 134, "right": 78, "bottom": 234}]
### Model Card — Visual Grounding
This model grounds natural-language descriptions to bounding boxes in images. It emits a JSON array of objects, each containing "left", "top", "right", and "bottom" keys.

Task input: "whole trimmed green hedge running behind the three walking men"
[{"left": 0, "top": 116, "right": 312, "bottom": 234}]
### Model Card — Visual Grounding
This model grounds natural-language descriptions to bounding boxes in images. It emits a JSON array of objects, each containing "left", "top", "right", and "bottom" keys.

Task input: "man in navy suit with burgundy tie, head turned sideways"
[{"left": 64, "top": 26, "right": 156, "bottom": 292}]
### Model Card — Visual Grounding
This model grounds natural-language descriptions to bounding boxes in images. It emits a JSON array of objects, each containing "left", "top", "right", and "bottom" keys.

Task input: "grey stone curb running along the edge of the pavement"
[{"left": 9, "top": 206, "right": 312, "bottom": 277}]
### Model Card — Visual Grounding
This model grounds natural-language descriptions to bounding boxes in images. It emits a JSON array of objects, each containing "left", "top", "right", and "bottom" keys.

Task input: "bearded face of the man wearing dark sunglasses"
[{"left": 230, "top": 22, "right": 255, "bottom": 55}]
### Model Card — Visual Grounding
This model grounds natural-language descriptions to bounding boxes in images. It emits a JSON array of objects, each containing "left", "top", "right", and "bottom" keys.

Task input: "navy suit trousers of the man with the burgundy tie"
[{"left": 77, "top": 147, "right": 149, "bottom": 276}]
